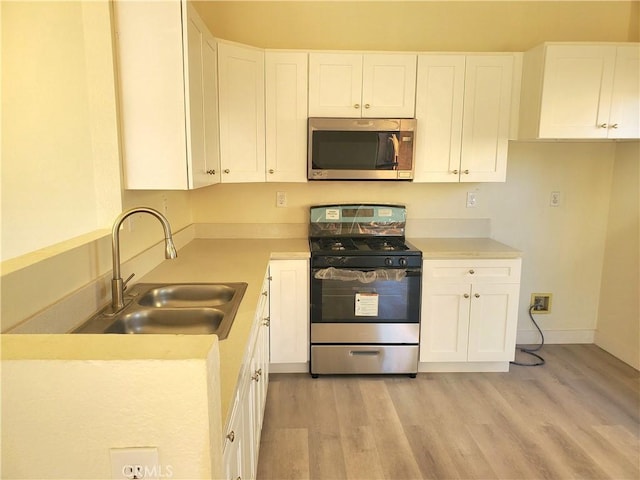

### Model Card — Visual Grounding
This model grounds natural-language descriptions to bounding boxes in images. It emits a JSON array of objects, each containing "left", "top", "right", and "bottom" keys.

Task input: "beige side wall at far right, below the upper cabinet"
[{"left": 596, "top": 142, "right": 640, "bottom": 370}]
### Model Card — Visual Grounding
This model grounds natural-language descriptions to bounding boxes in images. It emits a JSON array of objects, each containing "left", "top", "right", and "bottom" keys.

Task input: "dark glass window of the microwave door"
[{"left": 311, "top": 130, "right": 398, "bottom": 170}]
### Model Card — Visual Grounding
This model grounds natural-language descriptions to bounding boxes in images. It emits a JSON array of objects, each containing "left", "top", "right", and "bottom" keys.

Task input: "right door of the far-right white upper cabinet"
[{"left": 608, "top": 44, "right": 640, "bottom": 138}]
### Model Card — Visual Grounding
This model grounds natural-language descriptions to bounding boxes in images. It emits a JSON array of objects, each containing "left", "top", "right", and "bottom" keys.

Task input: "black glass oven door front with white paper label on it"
[{"left": 311, "top": 271, "right": 420, "bottom": 323}]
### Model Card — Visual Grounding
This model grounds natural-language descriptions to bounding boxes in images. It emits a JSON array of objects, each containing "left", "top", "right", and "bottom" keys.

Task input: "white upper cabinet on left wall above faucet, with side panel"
[{"left": 114, "top": 0, "right": 220, "bottom": 190}]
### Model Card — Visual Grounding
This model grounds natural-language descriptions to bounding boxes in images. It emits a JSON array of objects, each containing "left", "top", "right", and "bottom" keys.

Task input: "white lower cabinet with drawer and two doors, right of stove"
[{"left": 420, "top": 259, "right": 521, "bottom": 371}]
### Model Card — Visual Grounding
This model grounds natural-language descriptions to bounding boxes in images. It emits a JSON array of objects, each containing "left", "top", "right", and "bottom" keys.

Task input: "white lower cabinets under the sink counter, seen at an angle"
[{"left": 222, "top": 276, "right": 269, "bottom": 480}]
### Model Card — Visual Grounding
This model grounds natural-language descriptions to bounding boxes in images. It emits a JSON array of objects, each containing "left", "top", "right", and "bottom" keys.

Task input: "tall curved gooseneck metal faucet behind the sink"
[{"left": 111, "top": 207, "right": 178, "bottom": 313}]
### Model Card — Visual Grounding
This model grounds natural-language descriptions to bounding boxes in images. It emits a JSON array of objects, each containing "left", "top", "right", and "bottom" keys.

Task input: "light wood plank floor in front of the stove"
[{"left": 258, "top": 345, "right": 640, "bottom": 480}]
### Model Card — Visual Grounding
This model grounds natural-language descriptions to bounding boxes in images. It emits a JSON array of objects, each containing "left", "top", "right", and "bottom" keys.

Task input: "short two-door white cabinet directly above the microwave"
[{"left": 309, "top": 53, "right": 416, "bottom": 118}]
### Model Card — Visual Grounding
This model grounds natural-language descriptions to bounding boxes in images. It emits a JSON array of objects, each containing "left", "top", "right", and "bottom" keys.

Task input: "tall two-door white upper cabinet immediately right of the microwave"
[{"left": 414, "top": 54, "right": 514, "bottom": 182}]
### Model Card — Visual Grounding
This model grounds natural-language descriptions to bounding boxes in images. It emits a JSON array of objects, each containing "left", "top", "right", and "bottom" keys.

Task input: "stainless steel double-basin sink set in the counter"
[{"left": 73, "top": 283, "right": 247, "bottom": 340}]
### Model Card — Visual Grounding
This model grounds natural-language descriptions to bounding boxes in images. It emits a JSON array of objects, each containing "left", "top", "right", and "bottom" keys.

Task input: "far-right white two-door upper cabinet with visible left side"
[{"left": 520, "top": 43, "right": 640, "bottom": 139}]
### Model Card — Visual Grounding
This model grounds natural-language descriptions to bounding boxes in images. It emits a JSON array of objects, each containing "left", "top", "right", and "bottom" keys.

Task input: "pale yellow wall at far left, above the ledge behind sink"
[{"left": 1, "top": 0, "right": 121, "bottom": 260}]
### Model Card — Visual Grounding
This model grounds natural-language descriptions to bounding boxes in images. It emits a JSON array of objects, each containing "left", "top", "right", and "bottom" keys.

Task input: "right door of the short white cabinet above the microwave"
[{"left": 361, "top": 54, "right": 416, "bottom": 118}]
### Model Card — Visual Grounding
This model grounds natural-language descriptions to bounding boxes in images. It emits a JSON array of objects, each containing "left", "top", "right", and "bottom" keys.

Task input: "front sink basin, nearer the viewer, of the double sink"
[{"left": 104, "top": 308, "right": 224, "bottom": 334}]
